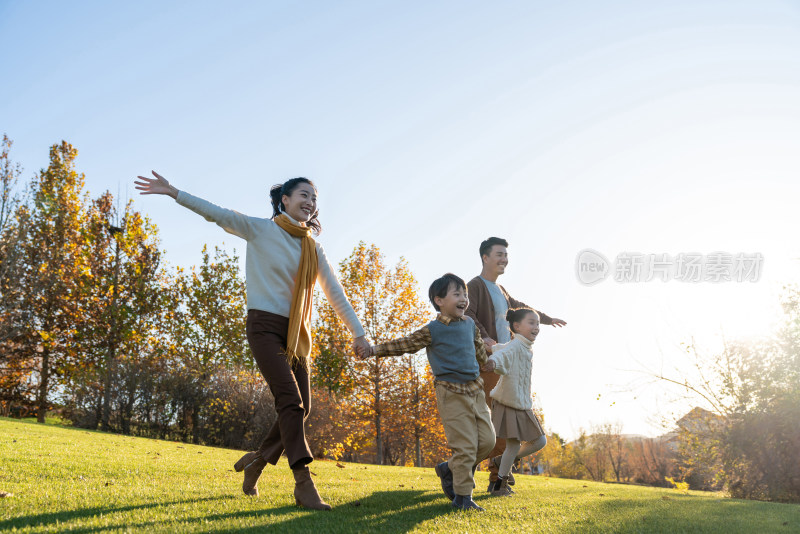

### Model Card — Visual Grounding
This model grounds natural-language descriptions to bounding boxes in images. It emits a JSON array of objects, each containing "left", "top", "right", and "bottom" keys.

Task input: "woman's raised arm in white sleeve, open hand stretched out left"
[{"left": 134, "top": 171, "right": 257, "bottom": 240}]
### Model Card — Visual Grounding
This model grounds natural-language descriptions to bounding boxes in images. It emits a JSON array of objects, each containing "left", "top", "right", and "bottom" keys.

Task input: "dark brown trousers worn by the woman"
[{"left": 247, "top": 310, "right": 314, "bottom": 469}]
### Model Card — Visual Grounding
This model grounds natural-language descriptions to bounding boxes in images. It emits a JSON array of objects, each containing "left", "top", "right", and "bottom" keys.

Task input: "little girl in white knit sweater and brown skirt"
[{"left": 483, "top": 308, "right": 547, "bottom": 496}]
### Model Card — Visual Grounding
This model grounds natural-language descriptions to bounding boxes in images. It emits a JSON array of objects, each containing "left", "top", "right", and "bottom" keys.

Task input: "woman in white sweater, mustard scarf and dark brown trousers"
[{"left": 135, "top": 171, "right": 369, "bottom": 510}]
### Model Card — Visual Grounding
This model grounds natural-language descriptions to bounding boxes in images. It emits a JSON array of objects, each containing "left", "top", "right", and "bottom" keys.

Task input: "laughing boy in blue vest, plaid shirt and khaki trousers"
[{"left": 370, "top": 273, "right": 495, "bottom": 511}]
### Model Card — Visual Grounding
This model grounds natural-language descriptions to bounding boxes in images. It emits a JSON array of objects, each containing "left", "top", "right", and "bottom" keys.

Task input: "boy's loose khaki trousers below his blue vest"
[{"left": 436, "top": 384, "right": 495, "bottom": 495}]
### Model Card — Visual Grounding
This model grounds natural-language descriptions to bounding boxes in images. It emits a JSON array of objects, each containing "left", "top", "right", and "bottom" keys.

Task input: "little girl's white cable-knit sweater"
[{"left": 489, "top": 335, "right": 533, "bottom": 410}]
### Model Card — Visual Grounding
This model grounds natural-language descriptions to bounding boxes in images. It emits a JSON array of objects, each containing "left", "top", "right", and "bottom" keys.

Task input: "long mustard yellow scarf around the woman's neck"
[{"left": 275, "top": 213, "right": 317, "bottom": 368}]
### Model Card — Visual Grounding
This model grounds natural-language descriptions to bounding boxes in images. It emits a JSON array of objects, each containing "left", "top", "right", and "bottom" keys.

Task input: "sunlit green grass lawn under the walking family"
[{"left": 0, "top": 418, "right": 800, "bottom": 534}]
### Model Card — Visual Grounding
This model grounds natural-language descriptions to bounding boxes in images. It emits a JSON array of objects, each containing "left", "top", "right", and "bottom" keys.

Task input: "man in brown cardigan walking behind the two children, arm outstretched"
[{"left": 466, "top": 237, "right": 567, "bottom": 491}]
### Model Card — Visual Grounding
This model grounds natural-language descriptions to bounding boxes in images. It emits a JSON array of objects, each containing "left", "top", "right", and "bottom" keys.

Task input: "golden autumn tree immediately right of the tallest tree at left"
[{"left": 69, "top": 192, "right": 168, "bottom": 433}]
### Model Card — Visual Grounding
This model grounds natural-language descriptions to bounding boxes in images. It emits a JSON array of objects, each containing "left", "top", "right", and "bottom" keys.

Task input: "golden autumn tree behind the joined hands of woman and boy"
[{"left": 314, "top": 242, "right": 444, "bottom": 464}]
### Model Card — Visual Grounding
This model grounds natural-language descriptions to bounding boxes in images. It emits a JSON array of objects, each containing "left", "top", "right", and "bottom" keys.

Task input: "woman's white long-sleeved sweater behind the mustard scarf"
[{"left": 176, "top": 191, "right": 364, "bottom": 337}]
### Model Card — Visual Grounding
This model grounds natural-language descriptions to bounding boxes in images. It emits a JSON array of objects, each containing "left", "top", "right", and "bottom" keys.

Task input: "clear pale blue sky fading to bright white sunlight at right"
[{"left": 0, "top": 0, "right": 800, "bottom": 442}]
